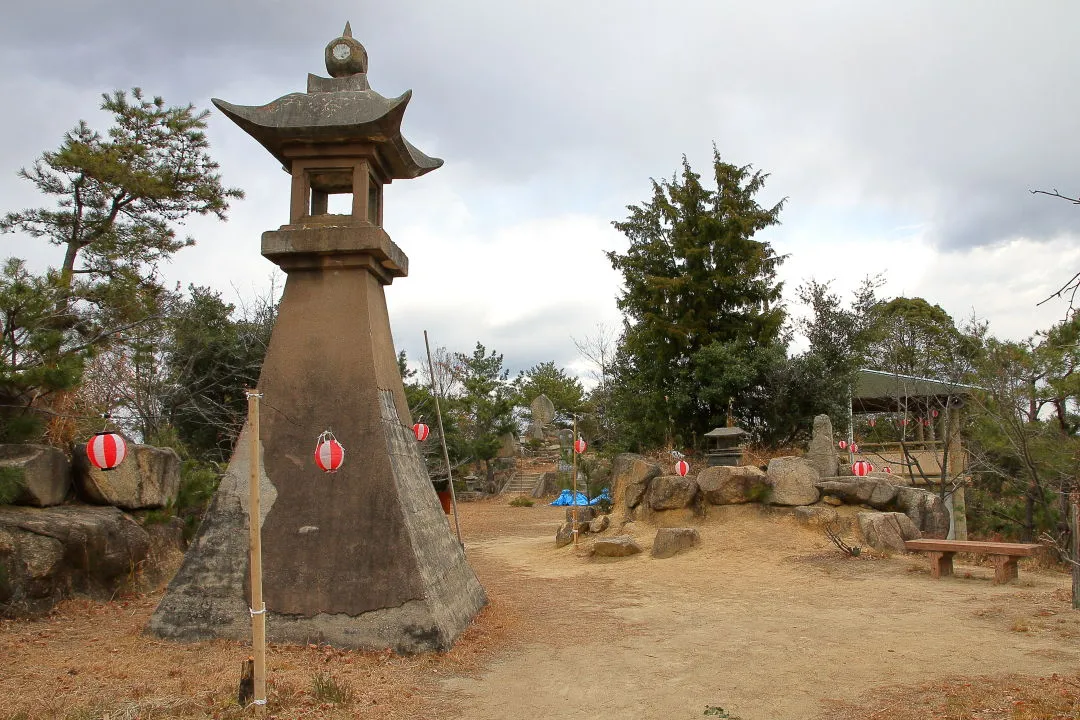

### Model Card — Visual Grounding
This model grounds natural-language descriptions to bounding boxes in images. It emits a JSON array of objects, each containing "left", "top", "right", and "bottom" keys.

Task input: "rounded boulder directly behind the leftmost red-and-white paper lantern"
[{"left": 71, "top": 444, "right": 180, "bottom": 510}]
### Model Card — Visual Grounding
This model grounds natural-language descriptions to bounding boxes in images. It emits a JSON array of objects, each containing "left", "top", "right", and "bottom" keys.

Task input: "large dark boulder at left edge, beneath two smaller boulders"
[{"left": 0, "top": 505, "right": 150, "bottom": 614}]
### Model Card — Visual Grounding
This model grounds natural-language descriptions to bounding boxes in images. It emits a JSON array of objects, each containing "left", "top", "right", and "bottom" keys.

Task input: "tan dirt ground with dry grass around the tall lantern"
[{"left": 0, "top": 498, "right": 1080, "bottom": 720}]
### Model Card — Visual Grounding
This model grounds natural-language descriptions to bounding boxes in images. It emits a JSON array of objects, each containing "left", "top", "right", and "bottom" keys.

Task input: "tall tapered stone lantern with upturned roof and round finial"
[{"left": 148, "top": 25, "right": 486, "bottom": 652}]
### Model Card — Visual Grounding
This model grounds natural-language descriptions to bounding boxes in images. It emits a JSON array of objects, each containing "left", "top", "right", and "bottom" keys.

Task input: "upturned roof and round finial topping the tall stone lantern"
[{"left": 212, "top": 24, "right": 443, "bottom": 180}]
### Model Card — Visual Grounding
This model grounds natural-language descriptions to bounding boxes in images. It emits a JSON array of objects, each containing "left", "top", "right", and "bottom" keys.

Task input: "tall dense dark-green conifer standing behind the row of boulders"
[{"left": 607, "top": 148, "right": 786, "bottom": 446}]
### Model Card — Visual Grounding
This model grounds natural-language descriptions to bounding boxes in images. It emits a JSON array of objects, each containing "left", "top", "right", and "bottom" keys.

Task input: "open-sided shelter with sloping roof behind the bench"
[{"left": 848, "top": 369, "right": 977, "bottom": 540}]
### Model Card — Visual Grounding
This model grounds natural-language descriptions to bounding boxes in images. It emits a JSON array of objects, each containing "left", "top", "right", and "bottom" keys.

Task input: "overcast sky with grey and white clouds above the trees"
[{"left": 0, "top": 0, "right": 1080, "bottom": 382}]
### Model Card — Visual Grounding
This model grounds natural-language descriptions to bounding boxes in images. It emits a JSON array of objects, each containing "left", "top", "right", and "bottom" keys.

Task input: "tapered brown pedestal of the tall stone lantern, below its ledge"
[{"left": 147, "top": 243, "right": 486, "bottom": 653}]
